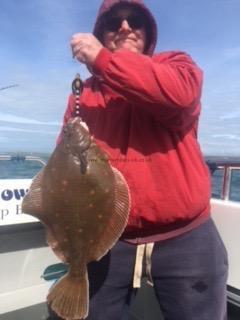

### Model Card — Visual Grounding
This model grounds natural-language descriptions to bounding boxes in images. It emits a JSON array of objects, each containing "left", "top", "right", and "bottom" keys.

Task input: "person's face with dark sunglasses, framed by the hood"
[{"left": 103, "top": 7, "right": 146, "bottom": 53}]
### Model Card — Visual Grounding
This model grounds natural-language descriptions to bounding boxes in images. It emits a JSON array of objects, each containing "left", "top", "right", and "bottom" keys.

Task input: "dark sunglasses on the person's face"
[{"left": 104, "top": 14, "right": 145, "bottom": 32}]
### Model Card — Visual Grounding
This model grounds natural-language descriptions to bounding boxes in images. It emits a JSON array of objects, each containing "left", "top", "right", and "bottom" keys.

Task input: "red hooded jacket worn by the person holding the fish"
[{"left": 57, "top": 0, "right": 210, "bottom": 243}]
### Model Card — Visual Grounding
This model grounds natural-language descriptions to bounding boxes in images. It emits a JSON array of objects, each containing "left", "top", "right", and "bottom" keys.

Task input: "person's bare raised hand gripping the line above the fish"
[{"left": 70, "top": 33, "right": 103, "bottom": 66}]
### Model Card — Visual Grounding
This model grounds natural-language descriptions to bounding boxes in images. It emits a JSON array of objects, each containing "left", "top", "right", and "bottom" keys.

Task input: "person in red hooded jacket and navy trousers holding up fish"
[{"left": 55, "top": 0, "right": 228, "bottom": 320}]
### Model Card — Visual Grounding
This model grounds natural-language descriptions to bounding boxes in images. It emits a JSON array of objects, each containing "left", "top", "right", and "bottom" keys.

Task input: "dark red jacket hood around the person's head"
[{"left": 93, "top": 0, "right": 157, "bottom": 56}]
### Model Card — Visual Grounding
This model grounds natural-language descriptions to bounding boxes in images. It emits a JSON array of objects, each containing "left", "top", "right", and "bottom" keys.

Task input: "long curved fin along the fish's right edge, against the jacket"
[{"left": 90, "top": 168, "right": 131, "bottom": 260}]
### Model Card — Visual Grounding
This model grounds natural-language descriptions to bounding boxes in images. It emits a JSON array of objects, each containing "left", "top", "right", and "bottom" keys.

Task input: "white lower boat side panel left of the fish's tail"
[{"left": 0, "top": 247, "right": 58, "bottom": 314}]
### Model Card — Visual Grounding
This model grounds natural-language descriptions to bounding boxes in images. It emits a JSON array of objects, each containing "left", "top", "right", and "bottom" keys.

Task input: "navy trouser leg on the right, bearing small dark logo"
[{"left": 152, "top": 219, "right": 228, "bottom": 320}]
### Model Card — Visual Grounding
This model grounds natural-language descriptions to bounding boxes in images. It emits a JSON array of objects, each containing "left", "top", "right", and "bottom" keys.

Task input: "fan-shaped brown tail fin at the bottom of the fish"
[{"left": 47, "top": 269, "right": 89, "bottom": 320}]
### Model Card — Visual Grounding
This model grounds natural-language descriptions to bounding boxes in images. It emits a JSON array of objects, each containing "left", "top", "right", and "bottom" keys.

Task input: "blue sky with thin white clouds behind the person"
[{"left": 0, "top": 0, "right": 240, "bottom": 156}]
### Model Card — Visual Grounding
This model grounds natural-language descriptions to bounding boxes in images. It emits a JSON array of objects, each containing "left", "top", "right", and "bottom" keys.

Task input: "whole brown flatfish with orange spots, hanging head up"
[{"left": 22, "top": 118, "right": 130, "bottom": 319}]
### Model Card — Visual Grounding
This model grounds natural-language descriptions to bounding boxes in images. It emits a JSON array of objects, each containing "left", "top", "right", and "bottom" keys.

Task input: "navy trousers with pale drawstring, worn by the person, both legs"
[{"left": 48, "top": 219, "right": 228, "bottom": 320}]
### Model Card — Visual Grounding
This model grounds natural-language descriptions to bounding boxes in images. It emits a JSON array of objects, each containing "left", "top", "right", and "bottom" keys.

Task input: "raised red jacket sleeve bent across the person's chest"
[{"left": 93, "top": 48, "right": 202, "bottom": 112}]
